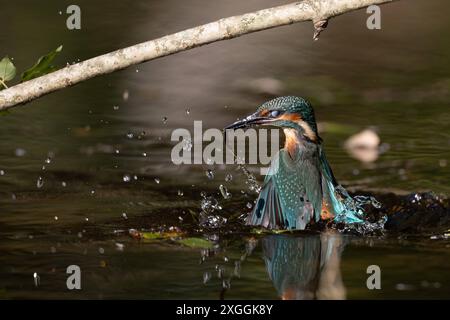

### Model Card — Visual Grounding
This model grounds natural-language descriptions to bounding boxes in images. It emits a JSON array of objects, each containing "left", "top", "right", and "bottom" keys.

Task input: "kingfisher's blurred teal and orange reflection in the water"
[{"left": 261, "top": 232, "right": 346, "bottom": 299}]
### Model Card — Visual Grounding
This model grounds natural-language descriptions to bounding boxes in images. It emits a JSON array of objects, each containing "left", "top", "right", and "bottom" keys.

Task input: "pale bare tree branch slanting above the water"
[{"left": 0, "top": 0, "right": 395, "bottom": 111}]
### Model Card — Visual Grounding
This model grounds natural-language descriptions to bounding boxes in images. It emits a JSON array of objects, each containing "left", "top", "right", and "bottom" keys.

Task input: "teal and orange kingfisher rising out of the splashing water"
[{"left": 225, "top": 96, "right": 364, "bottom": 230}]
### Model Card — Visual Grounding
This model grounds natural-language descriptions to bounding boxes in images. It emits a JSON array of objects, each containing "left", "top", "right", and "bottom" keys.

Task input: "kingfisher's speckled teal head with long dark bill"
[{"left": 225, "top": 96, "right": 321, "bottom": 143}]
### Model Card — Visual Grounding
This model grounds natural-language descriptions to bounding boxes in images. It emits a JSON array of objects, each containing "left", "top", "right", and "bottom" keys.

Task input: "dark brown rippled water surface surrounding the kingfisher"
[{"left": 0, "top": 0, "right": 450, "bottom": 299}]
